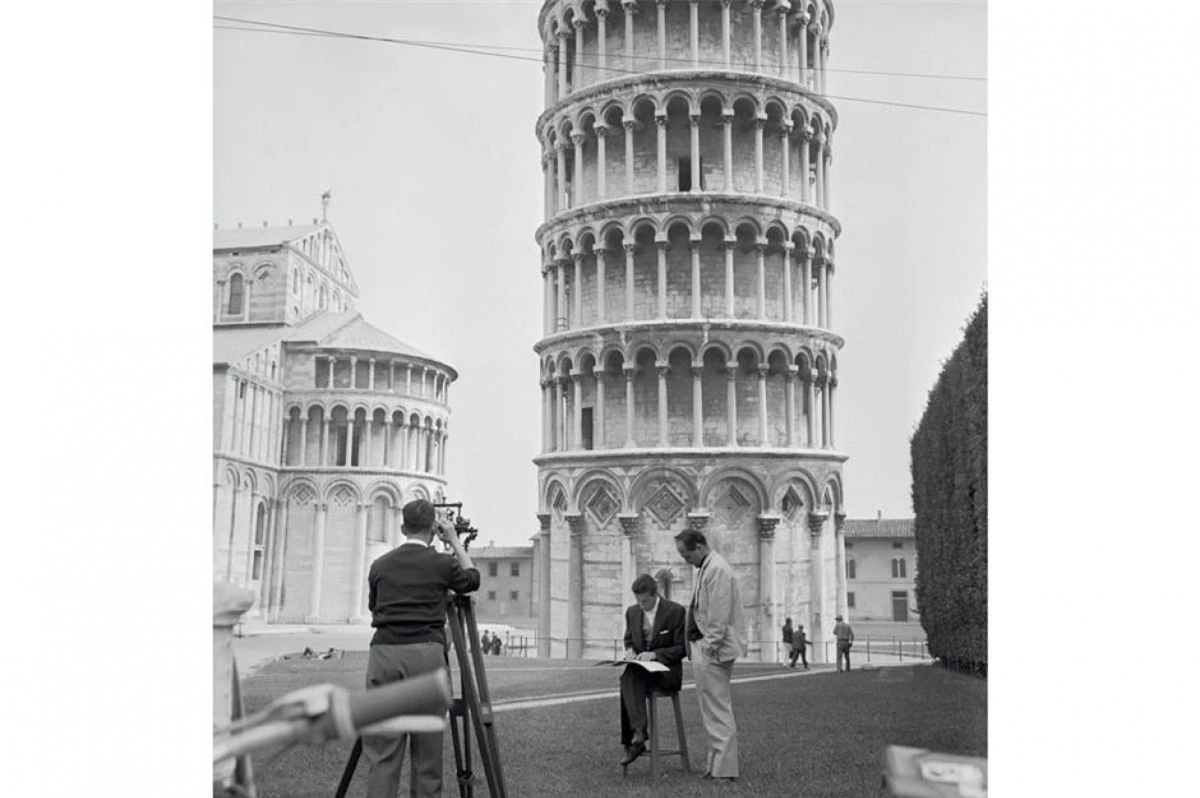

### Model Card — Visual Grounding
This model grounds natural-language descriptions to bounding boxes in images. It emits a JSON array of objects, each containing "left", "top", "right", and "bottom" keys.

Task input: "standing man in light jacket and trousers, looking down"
[{"left": 676, "top": 529, "right": 746, "bottom": 781}]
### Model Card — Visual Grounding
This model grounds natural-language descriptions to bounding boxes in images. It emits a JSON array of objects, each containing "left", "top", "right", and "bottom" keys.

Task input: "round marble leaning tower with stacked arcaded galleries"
[{"left": 534, "top": 0, "right": 846, "bottom": 661}]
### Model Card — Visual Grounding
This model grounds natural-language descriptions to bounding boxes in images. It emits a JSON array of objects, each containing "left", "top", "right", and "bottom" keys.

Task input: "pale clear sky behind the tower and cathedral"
[{"left": 212, "top": 0, "right": 988, "bottom": 545}]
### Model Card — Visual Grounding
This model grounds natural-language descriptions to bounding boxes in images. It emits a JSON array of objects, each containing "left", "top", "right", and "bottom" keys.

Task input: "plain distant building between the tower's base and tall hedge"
[{"left": 844, "top": 516, "right": 918, "bottom": 622}]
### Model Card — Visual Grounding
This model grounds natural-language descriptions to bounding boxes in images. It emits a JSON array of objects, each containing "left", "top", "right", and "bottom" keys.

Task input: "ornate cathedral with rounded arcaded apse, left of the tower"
[{"left": 212, "top": 221, "right": 457, "bottom": 623}]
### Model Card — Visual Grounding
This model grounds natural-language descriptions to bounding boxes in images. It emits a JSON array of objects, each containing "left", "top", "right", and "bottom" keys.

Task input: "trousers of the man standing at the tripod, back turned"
[{"left": 362, "top": 642, "right": 446, "bottom": 798}]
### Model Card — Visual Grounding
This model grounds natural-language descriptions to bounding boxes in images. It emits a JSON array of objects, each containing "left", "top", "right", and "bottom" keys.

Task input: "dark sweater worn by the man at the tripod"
[{"left": 367, "top": 544, "right": 479, "bottom": 646}]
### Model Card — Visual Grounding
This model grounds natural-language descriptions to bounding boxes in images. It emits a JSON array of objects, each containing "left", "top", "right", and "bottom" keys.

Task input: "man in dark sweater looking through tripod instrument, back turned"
[{"left": 362, "top": 499, "right": 479, "bottom": 798}]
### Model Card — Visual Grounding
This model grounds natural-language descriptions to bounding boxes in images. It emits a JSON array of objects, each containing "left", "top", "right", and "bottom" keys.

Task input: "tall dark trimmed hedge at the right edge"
[{"left": 911, "top": 294, "right": 988, "bottom": 672}]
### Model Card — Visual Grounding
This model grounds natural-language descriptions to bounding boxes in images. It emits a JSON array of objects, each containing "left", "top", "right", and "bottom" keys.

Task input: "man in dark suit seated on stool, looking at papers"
[{"left": 620, "top": 574, "right": 688, "bottom": 764}]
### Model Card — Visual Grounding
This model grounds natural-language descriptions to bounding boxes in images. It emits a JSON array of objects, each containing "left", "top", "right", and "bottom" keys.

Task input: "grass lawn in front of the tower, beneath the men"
[{"left": 236, "top": 653, "right": 988, "bottom": 798}]
